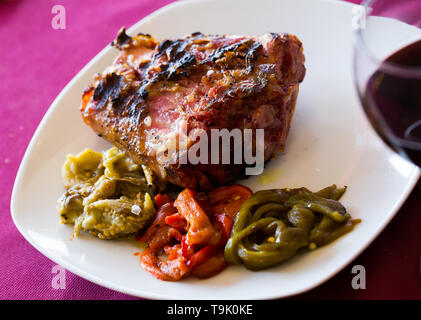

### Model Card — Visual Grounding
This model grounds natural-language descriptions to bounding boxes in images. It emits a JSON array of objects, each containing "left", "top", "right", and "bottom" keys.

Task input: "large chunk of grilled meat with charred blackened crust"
[{"left": 81, "top": 28, "right": 305, "bottom": 188}]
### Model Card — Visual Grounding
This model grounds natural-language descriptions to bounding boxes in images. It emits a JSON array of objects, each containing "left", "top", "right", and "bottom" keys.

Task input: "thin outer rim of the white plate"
[{"left": 10, "top": 0, "right": 421, "bottom": 300}]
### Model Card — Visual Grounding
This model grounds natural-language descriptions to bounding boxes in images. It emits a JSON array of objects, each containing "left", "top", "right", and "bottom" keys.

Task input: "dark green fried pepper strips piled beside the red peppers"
[{"left": 225, "top": 185, "right": 359, "bottom": 270}]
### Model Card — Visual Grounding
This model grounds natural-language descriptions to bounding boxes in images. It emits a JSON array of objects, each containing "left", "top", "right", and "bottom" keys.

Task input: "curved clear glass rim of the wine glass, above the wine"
[{"left": 355, "top": 0, "right": 421, "bottom": 78}]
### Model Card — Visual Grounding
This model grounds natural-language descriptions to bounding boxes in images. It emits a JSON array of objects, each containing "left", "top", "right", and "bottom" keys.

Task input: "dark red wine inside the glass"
[{"left": 362, "top": 40, "right": 421, "bottom": 166}]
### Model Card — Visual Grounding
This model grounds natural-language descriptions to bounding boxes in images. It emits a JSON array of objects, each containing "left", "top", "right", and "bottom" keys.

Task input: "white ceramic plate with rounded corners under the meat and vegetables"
[{"left": 11, "top": 0, "right": 419, "bottom": 299}]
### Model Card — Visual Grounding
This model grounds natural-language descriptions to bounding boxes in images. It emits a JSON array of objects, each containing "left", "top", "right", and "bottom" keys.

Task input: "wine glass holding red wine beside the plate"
[{"left": 354, "top": 0, "right": 421, "bottom": 166}]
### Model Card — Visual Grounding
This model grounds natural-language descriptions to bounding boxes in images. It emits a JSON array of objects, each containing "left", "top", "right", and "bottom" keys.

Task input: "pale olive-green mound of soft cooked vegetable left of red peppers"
[{"left": 57, "top": 147, "right": 155, "bottom": 239}]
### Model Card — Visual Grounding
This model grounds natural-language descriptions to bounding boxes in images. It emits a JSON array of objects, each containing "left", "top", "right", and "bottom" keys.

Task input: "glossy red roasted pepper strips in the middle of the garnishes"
[{"left": 139, "top": 185, "right": 252, "bottom": 281}]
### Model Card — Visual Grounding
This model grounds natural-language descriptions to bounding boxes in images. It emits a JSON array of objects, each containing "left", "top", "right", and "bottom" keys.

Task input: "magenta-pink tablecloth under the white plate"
[{"left": 0, "top": 0, "right": 421, "bottom": 299}]
